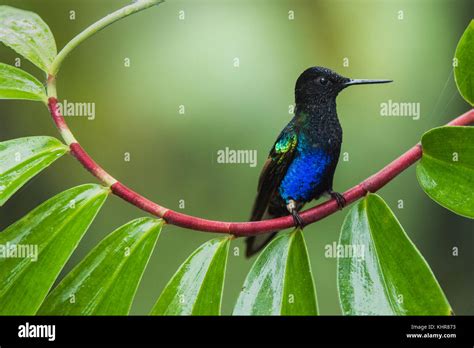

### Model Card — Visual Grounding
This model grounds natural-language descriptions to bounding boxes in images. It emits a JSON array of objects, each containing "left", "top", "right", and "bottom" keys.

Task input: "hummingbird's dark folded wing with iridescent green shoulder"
[{"left": 250, "top": 123, "right": 298, "bottom": 221}]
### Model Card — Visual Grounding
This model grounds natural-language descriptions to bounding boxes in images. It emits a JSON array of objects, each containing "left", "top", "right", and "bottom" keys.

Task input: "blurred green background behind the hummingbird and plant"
[{"left": 0, "top": 0, "right": 474, "bottom": 315}]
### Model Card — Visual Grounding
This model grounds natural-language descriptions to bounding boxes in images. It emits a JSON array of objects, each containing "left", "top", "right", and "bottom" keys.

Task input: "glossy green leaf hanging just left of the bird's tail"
[{"left": 150, "top": 238, "right": 230, "bottom": 315}]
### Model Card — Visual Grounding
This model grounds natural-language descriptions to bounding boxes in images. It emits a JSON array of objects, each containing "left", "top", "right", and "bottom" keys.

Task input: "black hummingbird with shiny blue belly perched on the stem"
[{"left": 245, "top": 66, "right": 392, "bottom": 257}]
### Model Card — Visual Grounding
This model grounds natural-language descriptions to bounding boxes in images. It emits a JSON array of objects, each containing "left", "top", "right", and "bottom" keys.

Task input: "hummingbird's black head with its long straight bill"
[{"left": 295, "top": 66, "right": 392, "bottom": 104}]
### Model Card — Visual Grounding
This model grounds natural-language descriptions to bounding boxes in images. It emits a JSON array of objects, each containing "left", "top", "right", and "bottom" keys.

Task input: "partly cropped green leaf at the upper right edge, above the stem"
[{"left": 454, "top": 20, "right": 474, "bottom": 105}]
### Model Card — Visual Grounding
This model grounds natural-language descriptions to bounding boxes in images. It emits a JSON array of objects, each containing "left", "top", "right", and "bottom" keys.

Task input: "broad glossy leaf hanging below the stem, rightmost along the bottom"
[{"left": 337, "top": 194, "right": 451, "bottom": 315}]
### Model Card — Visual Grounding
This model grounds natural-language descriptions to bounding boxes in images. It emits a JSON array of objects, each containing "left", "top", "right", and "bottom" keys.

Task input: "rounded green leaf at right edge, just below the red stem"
[{"left": 416, "top": 127, "right": 474, "bottom": 219}]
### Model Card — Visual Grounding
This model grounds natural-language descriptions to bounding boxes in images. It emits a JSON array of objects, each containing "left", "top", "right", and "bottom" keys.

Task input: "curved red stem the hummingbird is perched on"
[{"left": 48, "top": 98, "right": 474, "bottom": 236}]
